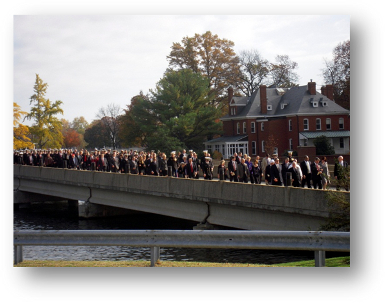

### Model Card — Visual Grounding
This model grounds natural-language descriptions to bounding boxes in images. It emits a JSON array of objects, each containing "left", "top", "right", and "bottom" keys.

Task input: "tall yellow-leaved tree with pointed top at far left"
[{"left": 25, "top": 74, "right": 63, "bottom": 148}]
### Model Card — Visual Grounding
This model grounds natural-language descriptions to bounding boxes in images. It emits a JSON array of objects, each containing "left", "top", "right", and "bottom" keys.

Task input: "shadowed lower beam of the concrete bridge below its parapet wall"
[{"left": 14, "top": 179, "right": 325, "bottom": 230}]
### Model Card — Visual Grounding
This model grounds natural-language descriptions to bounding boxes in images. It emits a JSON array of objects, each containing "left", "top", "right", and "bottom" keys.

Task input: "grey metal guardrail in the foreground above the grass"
[{"left": 13, "top": 230, "right": 350, "bottom": 267}]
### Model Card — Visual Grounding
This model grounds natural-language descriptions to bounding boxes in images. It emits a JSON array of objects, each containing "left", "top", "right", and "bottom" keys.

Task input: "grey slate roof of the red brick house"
[{"left": 221, "top": 85, "right": 350, "bottom": 120}]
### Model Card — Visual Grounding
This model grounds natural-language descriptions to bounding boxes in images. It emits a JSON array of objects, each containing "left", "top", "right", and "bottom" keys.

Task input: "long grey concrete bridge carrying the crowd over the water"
[{"left": 13, "top": 165, "right": 350, "bottom": 231}]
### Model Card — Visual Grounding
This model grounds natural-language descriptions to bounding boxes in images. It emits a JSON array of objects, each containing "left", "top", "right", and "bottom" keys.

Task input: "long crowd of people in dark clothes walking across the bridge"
[{"left": 13, "top": 149, "right": 349, "bottom": 190}]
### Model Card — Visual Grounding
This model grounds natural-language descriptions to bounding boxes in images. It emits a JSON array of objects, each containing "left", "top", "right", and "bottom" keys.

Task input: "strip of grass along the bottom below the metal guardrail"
[{"left": 14, "top": 256, "right": 350, "bottom": 267}]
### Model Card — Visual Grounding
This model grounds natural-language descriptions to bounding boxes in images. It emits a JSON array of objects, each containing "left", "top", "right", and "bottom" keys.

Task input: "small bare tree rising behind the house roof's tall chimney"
[{"left": 270, "top": 55, "right": 298, "bottom": 87}]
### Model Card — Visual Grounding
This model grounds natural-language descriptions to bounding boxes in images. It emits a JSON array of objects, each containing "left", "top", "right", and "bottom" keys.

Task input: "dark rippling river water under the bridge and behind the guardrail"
[{"left": 13, "top": 202, "right": 342, "bottom": 264}]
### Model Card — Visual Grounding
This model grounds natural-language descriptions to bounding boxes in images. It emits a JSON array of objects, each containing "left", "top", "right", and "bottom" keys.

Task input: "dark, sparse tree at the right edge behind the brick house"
[{"left": 323, "top": 40, "right": 350, "bottom": 110}]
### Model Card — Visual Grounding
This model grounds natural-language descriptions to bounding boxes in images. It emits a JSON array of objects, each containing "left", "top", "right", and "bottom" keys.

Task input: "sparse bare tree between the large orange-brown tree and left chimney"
[{"left": 238, "top": 50, "right": 270, "bottom": 96}]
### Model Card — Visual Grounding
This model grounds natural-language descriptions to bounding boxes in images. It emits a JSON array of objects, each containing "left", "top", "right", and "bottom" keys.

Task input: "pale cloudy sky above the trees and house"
[{"left": 13, "top": 14, "right": 350, "bottom": 126}]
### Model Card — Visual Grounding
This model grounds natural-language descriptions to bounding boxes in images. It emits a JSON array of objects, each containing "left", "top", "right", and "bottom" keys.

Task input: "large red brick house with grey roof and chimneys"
[{"left": 204, "top": 82, "right": 350, "bottom": 159}]
